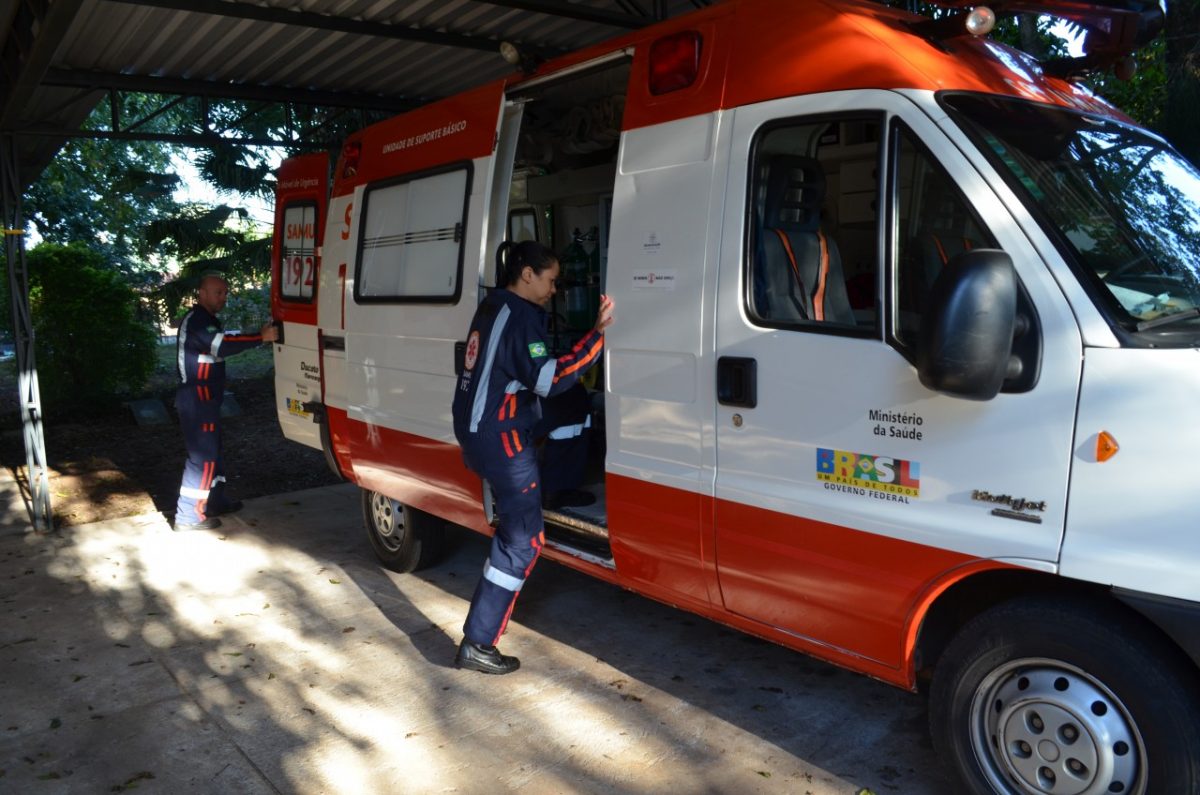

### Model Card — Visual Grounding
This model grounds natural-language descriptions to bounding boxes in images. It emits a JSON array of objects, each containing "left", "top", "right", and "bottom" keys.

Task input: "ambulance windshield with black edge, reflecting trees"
[{"left": 942, "top": 94, "right": 1200, "bottom": 343}]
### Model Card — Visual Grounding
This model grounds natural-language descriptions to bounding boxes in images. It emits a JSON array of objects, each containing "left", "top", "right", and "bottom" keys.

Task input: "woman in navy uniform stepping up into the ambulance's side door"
[{"left": 452, "top": 240, "right": 613, "bottom": 674}]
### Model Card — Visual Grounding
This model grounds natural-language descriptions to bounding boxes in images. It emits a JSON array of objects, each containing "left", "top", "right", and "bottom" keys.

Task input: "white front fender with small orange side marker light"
[{"left": 1061, "top": 348, "right": 1200, "bottom": 602}]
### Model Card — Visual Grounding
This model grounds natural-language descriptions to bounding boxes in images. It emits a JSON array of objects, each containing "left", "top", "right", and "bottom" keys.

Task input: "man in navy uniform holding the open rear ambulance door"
[{"left": 175, "top": 270, "right": 278, "bottom": 531}]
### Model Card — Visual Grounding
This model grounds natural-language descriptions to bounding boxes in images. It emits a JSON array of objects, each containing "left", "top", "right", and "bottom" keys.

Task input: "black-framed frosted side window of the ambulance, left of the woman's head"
[{"left": 354, "top": 165, "right": 470, "bottom": 303}]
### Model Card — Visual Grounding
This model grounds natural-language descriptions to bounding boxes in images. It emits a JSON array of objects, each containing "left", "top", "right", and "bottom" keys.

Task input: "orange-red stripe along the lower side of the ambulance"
[{"left": 340, "top": 416, "right": 1032, "bottom": 689}]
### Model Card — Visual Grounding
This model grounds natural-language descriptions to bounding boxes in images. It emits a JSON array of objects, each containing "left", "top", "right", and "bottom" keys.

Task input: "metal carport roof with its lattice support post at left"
[{"left": 0, "top": 0, "right": 709, "bottom": 530}]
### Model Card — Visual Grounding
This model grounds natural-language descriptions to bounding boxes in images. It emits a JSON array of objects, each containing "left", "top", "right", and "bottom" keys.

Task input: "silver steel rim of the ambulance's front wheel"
[{"left": 971, "top": 659, "right": 1146, "bottom": 795}]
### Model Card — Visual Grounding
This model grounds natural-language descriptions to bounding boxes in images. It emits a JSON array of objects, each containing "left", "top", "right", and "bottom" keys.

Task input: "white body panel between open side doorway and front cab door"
[{"left": 605, "top": 113, "right": 727, "bottom": 496}]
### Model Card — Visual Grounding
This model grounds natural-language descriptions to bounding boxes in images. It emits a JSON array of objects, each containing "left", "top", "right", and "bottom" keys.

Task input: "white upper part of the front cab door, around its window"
[{"left": 716, "top": 91, "right": 1082, "bottom": 566}]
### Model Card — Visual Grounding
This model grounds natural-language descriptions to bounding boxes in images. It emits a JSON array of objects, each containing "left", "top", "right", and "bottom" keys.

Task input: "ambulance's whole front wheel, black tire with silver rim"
[{"left": 929, "top": 599, "right": 1200, "bottom": 795}]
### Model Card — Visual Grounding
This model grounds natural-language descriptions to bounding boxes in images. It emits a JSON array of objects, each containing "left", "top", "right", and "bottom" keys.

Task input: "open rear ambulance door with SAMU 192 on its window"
[{"left": 271, "top": 153, "right": 329, "bottom": 449}]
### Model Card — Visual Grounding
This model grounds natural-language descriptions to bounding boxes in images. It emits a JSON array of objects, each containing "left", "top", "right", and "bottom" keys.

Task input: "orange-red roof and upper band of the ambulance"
[{"left": 324, "top": 0, "right": 1124, "bottom": 195}]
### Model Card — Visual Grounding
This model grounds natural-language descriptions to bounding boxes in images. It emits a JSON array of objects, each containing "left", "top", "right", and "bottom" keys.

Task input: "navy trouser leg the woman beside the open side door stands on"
[{"left": 462, "top": 444, "right": 542, "bottom": 645}]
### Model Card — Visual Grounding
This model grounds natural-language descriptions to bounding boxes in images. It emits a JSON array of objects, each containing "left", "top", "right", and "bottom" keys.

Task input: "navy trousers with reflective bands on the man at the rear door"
[{"left": 175, "top": 387, "right": 224, "bottom": 525}]
